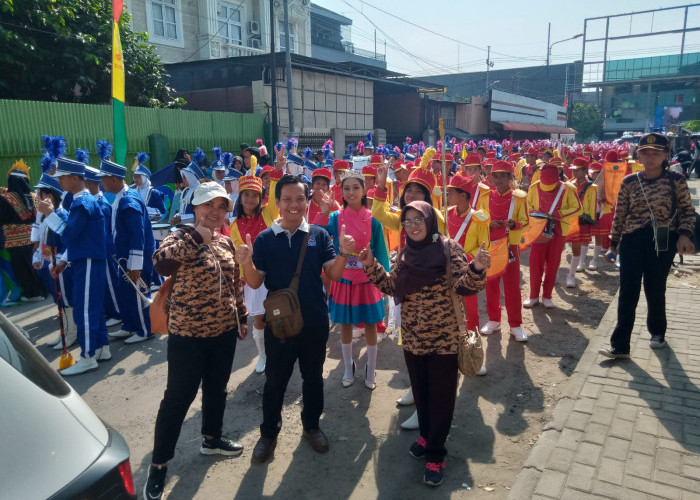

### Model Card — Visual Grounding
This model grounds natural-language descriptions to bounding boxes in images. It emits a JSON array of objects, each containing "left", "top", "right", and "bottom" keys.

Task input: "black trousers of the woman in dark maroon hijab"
[{"left": 403, "top": 350, "right": 458, "bottom": 462}]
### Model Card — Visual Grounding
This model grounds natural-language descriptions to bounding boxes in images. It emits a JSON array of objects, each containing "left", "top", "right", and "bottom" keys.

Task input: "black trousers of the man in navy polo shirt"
[{"left": 260, "top": 327, "right": 328, "bottom": 439}]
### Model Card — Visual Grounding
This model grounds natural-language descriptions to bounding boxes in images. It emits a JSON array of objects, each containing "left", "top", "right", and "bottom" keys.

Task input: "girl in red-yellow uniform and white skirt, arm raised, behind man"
[{"left": 229, "top": 154, "right": 285, "bottom": 373}]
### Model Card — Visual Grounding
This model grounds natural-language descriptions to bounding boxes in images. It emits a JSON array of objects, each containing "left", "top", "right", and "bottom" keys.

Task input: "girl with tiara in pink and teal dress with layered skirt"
[{"left": 313, "top": 170, "right": 389, "bottom": 390}]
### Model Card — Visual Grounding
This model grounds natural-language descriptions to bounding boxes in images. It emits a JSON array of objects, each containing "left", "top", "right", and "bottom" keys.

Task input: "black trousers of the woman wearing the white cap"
[{"left": 152, "top": 330, "right": 238, "bottom": 464}]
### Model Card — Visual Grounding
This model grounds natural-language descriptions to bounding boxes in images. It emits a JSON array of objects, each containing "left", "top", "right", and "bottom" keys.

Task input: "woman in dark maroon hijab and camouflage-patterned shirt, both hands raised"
[{"left": 358, "top": 201, "right": 491, "bottom": 486}]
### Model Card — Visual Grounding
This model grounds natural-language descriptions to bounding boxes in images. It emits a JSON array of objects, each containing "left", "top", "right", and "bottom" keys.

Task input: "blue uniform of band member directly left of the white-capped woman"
[{"left": 111, "top": 187, "right": 155, "bottom": 337}]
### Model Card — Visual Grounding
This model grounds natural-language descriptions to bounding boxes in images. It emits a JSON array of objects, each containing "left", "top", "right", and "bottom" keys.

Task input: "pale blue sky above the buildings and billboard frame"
[{"left": 313, "top": 0, "right": 700, "bottom": 76}]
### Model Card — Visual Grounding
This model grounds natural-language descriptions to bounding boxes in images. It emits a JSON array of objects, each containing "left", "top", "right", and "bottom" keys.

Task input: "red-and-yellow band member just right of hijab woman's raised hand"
[{"left": 481, "top": 161, "right": 527, "bottom": 342}]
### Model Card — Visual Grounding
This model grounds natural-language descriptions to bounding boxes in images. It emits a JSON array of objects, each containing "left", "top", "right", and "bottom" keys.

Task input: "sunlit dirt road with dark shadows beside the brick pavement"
[{"left": 13, "top": 240, "right": 676, "bottom": 500}]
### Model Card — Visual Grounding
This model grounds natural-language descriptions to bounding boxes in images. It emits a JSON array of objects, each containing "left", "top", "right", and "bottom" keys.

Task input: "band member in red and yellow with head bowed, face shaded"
[{"left": 523, "top": 164, "right": 581, "bottom": 309}]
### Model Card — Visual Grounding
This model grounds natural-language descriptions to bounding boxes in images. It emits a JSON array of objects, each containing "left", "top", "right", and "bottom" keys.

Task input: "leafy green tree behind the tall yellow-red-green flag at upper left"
[{"left": 0, "top": 0, "right": 185, "bottom": 108}]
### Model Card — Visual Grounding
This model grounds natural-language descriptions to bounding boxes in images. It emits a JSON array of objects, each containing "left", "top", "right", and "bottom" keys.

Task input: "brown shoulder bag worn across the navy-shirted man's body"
[{"left": 263, "top": 233, "right": 309, "bottom": 341}]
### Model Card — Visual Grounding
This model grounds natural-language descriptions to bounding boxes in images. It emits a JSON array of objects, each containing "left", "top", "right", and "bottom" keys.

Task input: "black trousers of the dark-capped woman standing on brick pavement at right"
[{"left": 610, "top": 226, "right": 678, "bottom": 352}]
